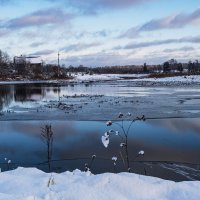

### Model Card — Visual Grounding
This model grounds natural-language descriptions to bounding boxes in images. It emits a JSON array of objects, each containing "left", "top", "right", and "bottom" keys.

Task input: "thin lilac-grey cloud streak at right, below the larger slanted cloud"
[{"left": 117, "top": 36, "right": 200, "bottom": 50}]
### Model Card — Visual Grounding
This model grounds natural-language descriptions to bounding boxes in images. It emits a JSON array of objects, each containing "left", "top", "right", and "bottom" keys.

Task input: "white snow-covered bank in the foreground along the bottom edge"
[{"left": 0, "top": 168, "right": 200, "bottom": 200}]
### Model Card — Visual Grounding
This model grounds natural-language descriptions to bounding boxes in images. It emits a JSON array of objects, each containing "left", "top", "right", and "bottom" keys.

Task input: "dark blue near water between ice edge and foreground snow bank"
[{"left": 0, "top": 119, "right": 200, "bottom": 181}]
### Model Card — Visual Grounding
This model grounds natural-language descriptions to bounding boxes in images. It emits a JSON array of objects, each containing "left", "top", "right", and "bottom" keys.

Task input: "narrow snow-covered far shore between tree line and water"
[{"left": 0, "top": 73, "right": 200, "bottom": 86}]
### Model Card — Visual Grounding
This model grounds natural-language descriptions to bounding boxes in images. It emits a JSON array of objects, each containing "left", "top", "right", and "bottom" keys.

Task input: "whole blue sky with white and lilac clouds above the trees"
[{"left": 0, "top": 0, "right": 200, "bottom": 67}]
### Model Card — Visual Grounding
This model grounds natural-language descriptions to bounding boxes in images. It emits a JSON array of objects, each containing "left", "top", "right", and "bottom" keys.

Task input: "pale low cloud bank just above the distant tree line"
[{"left": 51, "top": 45, "right": 199, "bottom": 67}]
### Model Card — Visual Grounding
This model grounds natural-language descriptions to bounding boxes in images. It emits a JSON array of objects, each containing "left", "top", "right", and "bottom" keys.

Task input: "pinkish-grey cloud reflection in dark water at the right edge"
[{"left": 147, "top": 119, "right": 200, "bottom": 134}]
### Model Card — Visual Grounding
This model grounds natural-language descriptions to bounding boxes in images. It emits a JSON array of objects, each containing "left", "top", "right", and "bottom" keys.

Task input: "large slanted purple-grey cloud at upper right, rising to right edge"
[{"left": 121, "top": 8, "right": 200, "bottom": 38}]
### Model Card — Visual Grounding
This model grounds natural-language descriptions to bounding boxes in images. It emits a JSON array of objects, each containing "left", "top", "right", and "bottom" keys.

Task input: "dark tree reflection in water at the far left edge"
[{"left": 0, "top": 85, "right": 13, "bottom": 111}]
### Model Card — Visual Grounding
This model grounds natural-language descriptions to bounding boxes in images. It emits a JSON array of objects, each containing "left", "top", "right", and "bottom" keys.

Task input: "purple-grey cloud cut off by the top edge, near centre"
[{"left": 47, "top": 0, "right": 155, "bottom": 15}]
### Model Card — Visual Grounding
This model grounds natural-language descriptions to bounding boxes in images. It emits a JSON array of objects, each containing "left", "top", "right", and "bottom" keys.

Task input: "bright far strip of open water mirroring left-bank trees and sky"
[{"left": 0, "top": 82, "right": 200, "bottom": 111}]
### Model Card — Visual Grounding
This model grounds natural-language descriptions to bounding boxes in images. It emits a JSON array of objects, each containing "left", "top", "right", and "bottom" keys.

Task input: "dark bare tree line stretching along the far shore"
[{"left": 0, "top": 50, "right": 200, "bottom": 80}]
